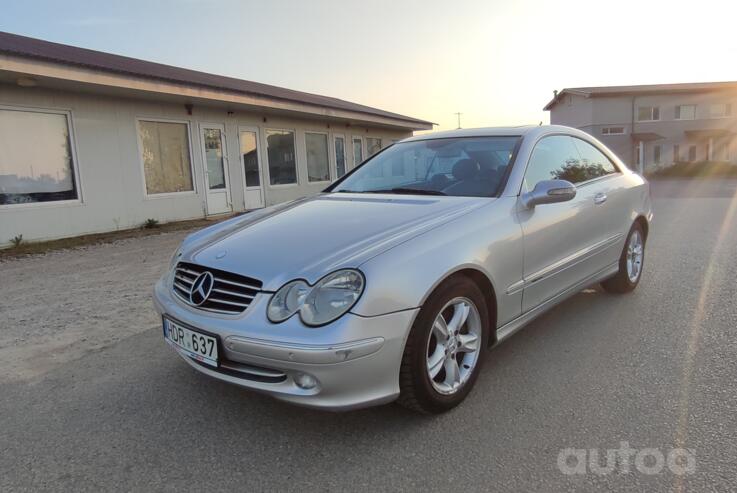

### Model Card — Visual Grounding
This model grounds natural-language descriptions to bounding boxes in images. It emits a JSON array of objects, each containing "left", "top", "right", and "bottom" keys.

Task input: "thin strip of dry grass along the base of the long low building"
[{"left": 0, "top": 216, "right": 233, "bottom": 260}]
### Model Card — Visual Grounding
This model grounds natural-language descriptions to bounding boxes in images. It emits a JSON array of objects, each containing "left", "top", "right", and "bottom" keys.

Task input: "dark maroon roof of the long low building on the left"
[{"left": 0, "top": 31, "right": 432, "bottom": 129}]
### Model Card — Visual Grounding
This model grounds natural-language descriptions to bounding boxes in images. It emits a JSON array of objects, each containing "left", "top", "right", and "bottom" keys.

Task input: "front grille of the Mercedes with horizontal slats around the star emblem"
[{"left": 173, "top": 262, "right": 263, "bottom": 314}]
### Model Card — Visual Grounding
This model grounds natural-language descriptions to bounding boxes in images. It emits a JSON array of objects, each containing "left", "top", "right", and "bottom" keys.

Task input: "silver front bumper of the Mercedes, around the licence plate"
[{"left": 154, "top": 277, "right": 418, "bottom": 410}]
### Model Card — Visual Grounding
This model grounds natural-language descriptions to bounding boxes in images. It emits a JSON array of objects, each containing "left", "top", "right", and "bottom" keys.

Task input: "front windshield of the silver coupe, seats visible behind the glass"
[{"left": 327, "top": 137, "right": 519, "bottom": 197}]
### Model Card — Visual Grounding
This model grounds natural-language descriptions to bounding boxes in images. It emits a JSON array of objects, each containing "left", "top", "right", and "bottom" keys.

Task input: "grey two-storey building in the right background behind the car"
[{"left": 544, "top": 82, "right": 737, "bottom": 172}]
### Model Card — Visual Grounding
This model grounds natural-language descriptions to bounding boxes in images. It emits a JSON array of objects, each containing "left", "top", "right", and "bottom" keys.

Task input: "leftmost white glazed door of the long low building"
[{"left": 200, "top": 123, "right": 233, "bottom": 216}]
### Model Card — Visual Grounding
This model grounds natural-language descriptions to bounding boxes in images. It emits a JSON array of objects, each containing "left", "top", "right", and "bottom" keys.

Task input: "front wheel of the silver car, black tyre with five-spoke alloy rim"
[{"left": 397, "top": 276, "right": 489, "bottom": 414}]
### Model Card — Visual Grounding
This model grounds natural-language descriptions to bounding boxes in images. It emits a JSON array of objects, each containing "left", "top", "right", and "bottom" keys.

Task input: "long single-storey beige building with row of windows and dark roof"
[{"left": 0, "top": 32, "right": 432, "bottom": 245}]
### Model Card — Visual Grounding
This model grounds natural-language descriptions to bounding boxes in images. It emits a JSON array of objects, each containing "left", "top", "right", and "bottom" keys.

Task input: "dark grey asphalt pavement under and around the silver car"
[{"left": 0, "top": 182, "right": 737, "bottom": 491}]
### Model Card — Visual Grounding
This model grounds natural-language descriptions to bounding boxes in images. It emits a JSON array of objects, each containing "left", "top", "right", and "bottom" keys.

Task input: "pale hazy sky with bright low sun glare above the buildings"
[{"left": 0, "top": 0, "right": 737, "bottom": 130}]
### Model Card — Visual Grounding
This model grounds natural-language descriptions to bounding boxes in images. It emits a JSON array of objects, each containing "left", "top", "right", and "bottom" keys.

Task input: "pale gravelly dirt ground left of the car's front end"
[{"left": 0, "top": 229, "right": 200, "bottom": 381}]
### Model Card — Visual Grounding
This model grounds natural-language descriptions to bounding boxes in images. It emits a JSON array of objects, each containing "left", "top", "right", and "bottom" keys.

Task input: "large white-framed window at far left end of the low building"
[{"left": 0, "top": 109, "right": 79, "bottom": 204}]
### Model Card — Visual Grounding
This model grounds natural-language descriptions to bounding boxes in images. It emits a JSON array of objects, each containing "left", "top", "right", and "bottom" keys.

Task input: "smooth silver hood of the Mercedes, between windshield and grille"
[{"left": 182, "top": 193, "right": 493, "bottom": 291}]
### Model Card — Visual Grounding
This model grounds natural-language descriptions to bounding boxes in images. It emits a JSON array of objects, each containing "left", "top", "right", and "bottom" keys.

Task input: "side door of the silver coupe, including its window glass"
[{"left": 518, "top": 135, "right": 606, "bottom": 312}]
